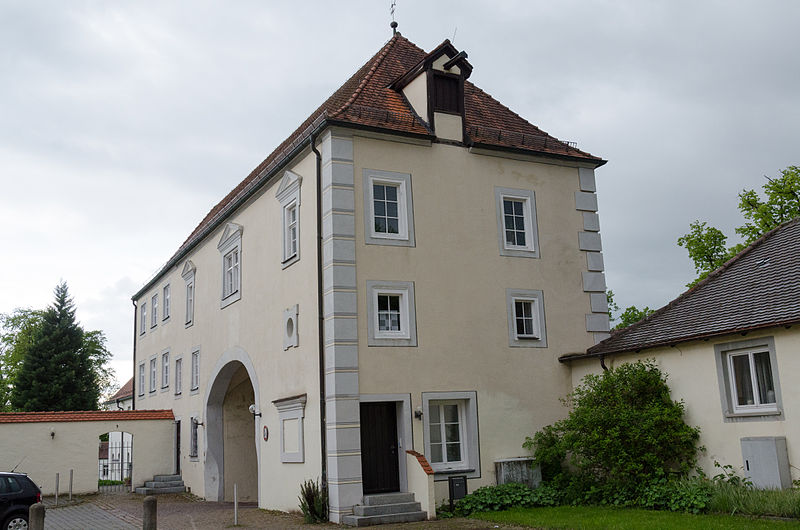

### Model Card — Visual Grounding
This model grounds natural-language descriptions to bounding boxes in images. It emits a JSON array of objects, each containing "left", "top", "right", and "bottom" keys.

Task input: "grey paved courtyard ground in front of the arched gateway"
[{"left": 40, "top": 493, "right": 514, "bottom": 530}]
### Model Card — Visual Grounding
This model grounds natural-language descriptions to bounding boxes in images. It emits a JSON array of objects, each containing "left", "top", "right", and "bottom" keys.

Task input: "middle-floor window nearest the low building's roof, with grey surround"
[{"left": 506, "top": 289, "right": 547, "bottom": 348}]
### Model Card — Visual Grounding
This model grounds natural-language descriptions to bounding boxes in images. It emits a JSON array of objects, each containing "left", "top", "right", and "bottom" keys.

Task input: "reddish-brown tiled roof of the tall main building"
[{"left": 133, "top": 33, "right": 605, "bottom": 299}]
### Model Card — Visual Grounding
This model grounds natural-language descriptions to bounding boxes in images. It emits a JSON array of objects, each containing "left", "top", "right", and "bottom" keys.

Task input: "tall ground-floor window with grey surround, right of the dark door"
[{"left": 422, "top": 391, "right": 480, "bottom": 478}]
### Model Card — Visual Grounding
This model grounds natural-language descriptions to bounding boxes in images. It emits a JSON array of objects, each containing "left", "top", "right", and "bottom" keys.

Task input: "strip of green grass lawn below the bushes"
[{"left": 471, "top": 506, "right": 800, "bottom": 530}]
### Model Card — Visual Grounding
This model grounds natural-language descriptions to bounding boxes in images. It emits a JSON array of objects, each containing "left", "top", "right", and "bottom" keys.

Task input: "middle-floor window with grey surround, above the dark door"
[{"left": 367, "top": 281, "right": 417, "bottom": 346}]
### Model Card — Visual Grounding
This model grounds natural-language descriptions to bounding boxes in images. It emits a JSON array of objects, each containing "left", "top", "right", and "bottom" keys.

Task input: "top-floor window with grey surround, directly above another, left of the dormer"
[{"left": 364, "top": 170, "right": 415, "bottom": 247}]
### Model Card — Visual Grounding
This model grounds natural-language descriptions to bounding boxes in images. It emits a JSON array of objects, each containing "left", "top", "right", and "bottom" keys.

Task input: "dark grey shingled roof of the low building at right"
[{"left": 560, "top": 218, "right": 800, "bottom": 361}]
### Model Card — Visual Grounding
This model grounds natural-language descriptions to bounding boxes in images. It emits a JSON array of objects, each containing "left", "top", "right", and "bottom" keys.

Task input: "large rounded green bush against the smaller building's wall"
[{"left": 523, "top": 361, "right": 700, "bottom": 490}]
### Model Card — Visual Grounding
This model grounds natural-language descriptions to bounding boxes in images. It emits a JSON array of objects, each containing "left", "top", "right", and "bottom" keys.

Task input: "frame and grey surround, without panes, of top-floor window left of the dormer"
[{"left": 364, "top": 169, "right": 416, "bottom": 247}]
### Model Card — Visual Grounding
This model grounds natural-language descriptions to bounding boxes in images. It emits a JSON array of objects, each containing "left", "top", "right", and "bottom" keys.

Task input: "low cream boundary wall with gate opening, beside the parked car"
[{"left": 0, "top": 420, "right": 173, "bottom": 495}]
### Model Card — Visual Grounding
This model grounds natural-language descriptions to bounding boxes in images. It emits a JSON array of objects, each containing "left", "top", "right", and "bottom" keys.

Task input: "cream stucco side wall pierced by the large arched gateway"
[{"left": 134, "top": 146, "right": 321, "bottom": 510}]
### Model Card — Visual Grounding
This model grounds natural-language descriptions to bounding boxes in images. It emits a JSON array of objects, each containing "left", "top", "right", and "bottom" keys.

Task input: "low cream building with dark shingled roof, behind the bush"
[{"left": 560, "top": 219, "right": 800, "bottom": 488}]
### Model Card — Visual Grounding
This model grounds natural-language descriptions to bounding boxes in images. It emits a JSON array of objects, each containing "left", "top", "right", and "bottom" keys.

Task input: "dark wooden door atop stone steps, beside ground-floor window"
[{"left": 361, "top": 402, "right": 400, "bottom": 495}]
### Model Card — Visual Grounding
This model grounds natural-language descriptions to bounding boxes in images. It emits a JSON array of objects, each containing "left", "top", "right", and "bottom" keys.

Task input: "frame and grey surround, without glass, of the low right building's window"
[{"left": 714, "top": 337, "right": 784, "bottom": 422}]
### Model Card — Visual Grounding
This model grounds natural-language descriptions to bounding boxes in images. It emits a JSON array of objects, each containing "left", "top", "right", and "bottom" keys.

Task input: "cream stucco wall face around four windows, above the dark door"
[{"left": 354, "top": 136, "right": 593, "bottom": 501}]
